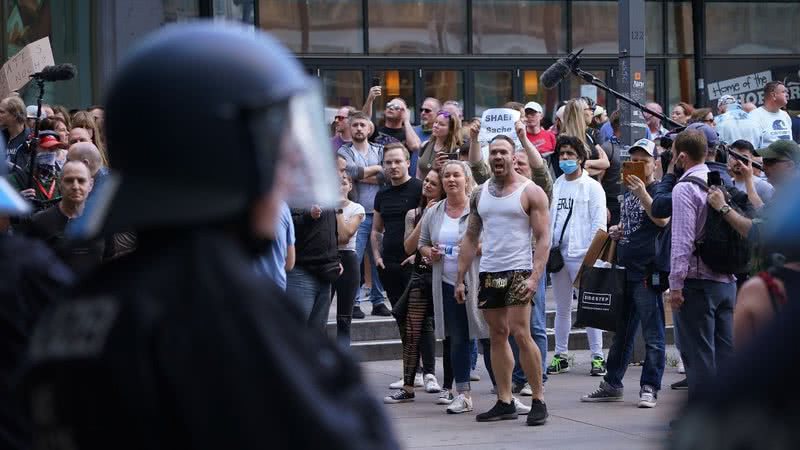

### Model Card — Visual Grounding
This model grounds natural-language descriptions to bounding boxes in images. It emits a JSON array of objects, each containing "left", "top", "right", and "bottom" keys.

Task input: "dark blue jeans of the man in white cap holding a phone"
[{"left": 605, "top": 281, "right": 665, "bottom": 391}]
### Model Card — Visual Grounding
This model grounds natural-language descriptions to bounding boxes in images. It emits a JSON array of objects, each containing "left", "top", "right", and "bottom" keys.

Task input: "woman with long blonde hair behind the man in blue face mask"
[{"left": 553, "top": 98, "right": 611, "bottom": 178}]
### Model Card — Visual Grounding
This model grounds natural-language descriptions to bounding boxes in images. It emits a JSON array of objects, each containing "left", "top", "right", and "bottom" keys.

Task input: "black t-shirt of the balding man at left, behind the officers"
[{"left": 30, "top": 204, "right": 105, "bottom": 275}]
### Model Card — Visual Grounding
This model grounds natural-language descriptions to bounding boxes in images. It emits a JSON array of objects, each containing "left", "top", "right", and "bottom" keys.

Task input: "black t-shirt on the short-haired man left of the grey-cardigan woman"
[{"left": 375, "top": 178, "right": 422, "bottom": 262}]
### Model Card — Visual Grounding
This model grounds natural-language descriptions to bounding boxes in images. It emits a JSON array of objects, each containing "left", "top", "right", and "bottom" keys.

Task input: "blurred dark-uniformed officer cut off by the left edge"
[{"left": 0, "top": 142, "right": 72, "bottom": 450}]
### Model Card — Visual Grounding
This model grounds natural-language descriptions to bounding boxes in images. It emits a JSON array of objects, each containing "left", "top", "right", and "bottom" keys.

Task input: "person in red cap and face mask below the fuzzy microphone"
[{"left": 10, "top": 131, "right": 67, "bottom": 211}]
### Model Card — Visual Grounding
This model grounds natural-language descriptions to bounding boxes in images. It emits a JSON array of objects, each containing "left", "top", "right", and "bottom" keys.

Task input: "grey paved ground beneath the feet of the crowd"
[{"left": 361, "top": 346, "right": 686, "bottom": 450}]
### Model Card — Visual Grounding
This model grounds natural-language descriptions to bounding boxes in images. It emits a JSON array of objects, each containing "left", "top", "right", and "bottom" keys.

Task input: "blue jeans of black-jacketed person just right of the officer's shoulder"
[{"left": 286, "top": 266, "right": 331, "bottom": 330}]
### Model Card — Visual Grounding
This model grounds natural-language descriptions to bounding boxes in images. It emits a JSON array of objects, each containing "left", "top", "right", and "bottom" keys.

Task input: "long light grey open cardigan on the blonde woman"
[{"left": 418, "top": 199, "right": 489, "bottom": 339}]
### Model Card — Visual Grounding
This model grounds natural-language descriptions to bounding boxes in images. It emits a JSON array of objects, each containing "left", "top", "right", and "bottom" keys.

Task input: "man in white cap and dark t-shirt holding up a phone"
[{"left": 581, "top": 139, "right": 669, "bottom": 408}]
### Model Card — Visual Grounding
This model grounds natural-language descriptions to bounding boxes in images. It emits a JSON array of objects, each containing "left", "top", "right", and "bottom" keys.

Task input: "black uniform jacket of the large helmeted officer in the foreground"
[{"left": 24, "top": 230, "right": 399, "bottom": 450}]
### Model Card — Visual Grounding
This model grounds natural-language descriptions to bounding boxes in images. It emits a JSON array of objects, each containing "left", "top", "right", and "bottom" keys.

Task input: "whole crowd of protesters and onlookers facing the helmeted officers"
[{"left": 0, "top": 38, "right": 800, "bottom": 440}]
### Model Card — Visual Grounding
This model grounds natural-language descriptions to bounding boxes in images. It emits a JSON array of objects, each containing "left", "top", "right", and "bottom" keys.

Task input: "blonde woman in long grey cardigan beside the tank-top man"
[{"left": 419, "top": 161, "right": 489, "bottom": 414}]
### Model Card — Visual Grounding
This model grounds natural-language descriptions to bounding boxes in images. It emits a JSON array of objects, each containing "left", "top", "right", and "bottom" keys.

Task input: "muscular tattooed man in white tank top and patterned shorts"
[{"left": 455, "top": 135, "right": 551, "bottom": 425}]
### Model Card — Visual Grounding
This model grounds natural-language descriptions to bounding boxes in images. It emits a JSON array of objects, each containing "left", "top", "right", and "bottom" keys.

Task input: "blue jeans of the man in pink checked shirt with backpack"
[{"left": 678, "top": 279, "right": 736, "bottom": 401}]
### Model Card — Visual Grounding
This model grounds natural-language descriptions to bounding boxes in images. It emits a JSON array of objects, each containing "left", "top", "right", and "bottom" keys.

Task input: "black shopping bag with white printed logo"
[{"left": 574, "top": 258, "right": 625, "bottom": 331}]
